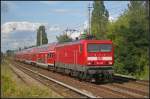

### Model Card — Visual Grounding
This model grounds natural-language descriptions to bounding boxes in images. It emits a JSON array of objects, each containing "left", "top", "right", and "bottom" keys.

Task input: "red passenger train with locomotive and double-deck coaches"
[{"left": 16, "top": 40, "right": 114, "bottom": 81}]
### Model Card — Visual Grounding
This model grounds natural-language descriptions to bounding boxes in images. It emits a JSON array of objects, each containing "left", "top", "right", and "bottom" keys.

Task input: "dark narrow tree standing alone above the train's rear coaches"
[{"left": 37, "top": 25, "right": 48, "bottom": 46}]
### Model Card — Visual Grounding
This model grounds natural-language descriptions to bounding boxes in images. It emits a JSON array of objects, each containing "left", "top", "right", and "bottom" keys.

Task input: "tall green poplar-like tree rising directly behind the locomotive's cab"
[{"left": 91, "top": 1, "right": 109, "bottom": 39}]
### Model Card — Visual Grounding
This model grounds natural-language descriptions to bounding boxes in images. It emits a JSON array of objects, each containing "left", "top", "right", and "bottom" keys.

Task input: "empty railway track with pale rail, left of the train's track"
[{"left": 10, "top": 64, "right": 97, "bottom": 98}]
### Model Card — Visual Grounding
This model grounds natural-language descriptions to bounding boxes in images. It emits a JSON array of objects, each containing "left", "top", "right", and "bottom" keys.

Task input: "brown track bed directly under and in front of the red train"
[{"left": 10, "top": 62, "right": 149, "bottom": 98}]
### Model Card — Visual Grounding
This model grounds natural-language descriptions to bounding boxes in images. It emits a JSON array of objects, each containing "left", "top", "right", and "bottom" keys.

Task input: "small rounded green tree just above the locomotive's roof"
[{"left": 56, "top": 34, "right": 72, "bottom": 43}]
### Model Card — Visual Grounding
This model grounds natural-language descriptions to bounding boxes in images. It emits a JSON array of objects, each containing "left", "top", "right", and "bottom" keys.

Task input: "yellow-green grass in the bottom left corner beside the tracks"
[{"left": 1, "top": 61, "right": 61, "bottom": 98}]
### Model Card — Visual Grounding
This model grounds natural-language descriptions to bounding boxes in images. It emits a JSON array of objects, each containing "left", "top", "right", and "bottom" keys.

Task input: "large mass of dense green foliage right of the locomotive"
[{"left": 107, "top": 1, "right": 149, "bottom": 76}]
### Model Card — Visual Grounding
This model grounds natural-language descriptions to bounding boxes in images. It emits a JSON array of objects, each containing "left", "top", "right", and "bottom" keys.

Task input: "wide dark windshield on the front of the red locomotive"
[{"left": 87, "top": 44, "right": 112, "bottom": 52}]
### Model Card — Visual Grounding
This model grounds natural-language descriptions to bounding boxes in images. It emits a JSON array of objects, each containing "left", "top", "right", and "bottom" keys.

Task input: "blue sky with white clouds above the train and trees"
[{"left": 1, "top": 1, "right": 129, "bottom": 52}]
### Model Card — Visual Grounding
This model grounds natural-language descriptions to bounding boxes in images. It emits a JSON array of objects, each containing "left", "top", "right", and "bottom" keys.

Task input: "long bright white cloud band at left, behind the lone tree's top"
[{"left": 1, "top": 21, "right": 59, "bottom": 37}]
